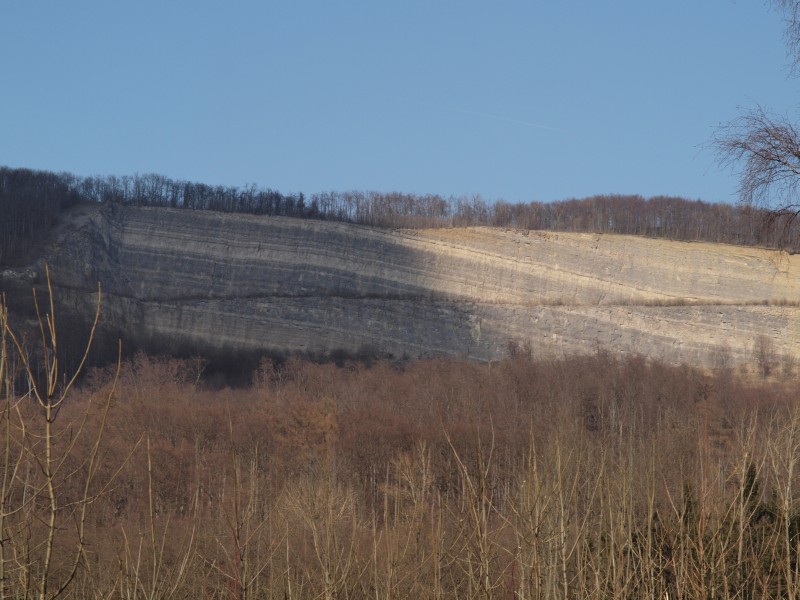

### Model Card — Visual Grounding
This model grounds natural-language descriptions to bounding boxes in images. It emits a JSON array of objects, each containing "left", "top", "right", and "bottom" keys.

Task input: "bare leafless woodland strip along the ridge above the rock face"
[{"left": 0, "top": 167, "right": 800, "bottom": 264}]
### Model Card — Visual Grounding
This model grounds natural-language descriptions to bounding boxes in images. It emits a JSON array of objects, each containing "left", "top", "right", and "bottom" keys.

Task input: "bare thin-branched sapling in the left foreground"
[{"left": 0, "top": 267, "right": 119, "bottom": 600}]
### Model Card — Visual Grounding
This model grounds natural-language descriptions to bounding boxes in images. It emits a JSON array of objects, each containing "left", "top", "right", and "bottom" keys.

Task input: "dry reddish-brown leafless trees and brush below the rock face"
[{"left": 0, "top": 290, "right": 800, "bottom": 599}]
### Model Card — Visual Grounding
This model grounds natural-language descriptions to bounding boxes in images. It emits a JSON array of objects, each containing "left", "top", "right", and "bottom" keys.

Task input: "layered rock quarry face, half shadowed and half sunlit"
[{"left": 10, "top": 206, "right": 800, "bottom": 365}]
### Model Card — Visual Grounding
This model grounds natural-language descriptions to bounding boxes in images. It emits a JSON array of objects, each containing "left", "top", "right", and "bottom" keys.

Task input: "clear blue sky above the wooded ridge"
[{"left": 0, "top": 0, "right": 800, "bottom": 202}]
